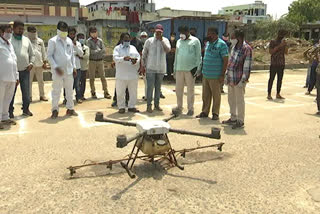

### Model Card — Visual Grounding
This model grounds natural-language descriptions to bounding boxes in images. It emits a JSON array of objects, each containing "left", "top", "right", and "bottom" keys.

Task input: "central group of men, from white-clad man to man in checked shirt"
[{"left": 113, "top": 24, "right": 252, "bottom": 129}]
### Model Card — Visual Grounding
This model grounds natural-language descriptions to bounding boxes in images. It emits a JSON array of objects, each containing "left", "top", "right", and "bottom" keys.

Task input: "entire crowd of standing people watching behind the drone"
[{"left": 0, "top": 21, "right": 320, "bottom": 129}]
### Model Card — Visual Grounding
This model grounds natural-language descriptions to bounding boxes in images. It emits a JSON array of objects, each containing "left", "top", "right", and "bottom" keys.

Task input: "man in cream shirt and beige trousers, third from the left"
[{"left": 27, "top": 26, "right": 48, "bottom": 102}]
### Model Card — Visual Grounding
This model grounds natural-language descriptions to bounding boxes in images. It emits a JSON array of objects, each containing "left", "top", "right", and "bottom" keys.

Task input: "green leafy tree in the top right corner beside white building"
[{"left": 287, "top": 0, "right": 320, "bottom": 26}]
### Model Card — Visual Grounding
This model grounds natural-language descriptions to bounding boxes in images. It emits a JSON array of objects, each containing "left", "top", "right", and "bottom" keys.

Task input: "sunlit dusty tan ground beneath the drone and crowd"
[{"left": 0, "top": 71, "right": 320, "bottom": 214}]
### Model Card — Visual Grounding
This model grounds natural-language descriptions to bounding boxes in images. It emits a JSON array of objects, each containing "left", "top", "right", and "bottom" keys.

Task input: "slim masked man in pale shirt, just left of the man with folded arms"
[{"left": 77, "top": 33, "right": 90, "bottom": 101}]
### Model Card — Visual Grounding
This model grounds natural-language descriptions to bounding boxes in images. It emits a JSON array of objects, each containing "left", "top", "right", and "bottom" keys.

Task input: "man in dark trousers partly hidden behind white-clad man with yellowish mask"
[{"left": 68, "top": 27, "right": 83, "bottom": 103}]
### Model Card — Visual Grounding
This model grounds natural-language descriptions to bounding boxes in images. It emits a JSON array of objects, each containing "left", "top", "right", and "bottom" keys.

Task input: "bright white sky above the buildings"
[{"left": 80, "top": 0, "right": 294, "bottom": 19}]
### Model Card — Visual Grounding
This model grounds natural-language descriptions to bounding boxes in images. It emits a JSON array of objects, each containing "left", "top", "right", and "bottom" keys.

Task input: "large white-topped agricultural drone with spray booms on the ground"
[{"left": 67, "top": 112, "right": 224, "bottom": 179}]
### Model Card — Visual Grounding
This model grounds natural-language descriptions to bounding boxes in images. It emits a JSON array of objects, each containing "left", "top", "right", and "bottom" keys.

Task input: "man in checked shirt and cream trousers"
[{"left": 222, "top": 30, "right": 252, "bottom": 129}]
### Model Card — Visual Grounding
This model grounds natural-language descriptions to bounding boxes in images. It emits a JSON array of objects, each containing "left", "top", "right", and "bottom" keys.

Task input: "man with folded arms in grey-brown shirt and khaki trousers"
[{"left": 87, "top": 27, "right": 111, "bottom": 99}]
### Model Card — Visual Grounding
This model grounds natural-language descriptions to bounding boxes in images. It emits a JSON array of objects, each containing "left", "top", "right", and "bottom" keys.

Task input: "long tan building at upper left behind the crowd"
[{"left": 0, "top": 0, "right": 88, "bottom": 42}]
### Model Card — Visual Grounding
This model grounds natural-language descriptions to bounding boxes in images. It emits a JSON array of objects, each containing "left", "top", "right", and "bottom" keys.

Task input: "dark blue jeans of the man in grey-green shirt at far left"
[{"left": 9, "top": 70, "right": 30, "bottom": 113}]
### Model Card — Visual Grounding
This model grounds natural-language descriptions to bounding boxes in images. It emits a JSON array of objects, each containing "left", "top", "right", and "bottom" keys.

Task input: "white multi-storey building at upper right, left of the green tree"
[{"left": 219, "top": 1, "right": 269, "bottom": 24}]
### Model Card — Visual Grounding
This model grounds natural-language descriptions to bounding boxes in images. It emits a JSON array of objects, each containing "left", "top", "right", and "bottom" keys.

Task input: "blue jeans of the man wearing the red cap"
[{"left": 146, "top": 72, "right": 164, "bottom": 107}]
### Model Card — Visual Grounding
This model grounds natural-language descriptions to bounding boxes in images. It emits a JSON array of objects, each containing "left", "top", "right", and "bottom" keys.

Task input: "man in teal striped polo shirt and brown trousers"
[{"left": 197, "top": 28, "right": 228, "bottom": 120}]
